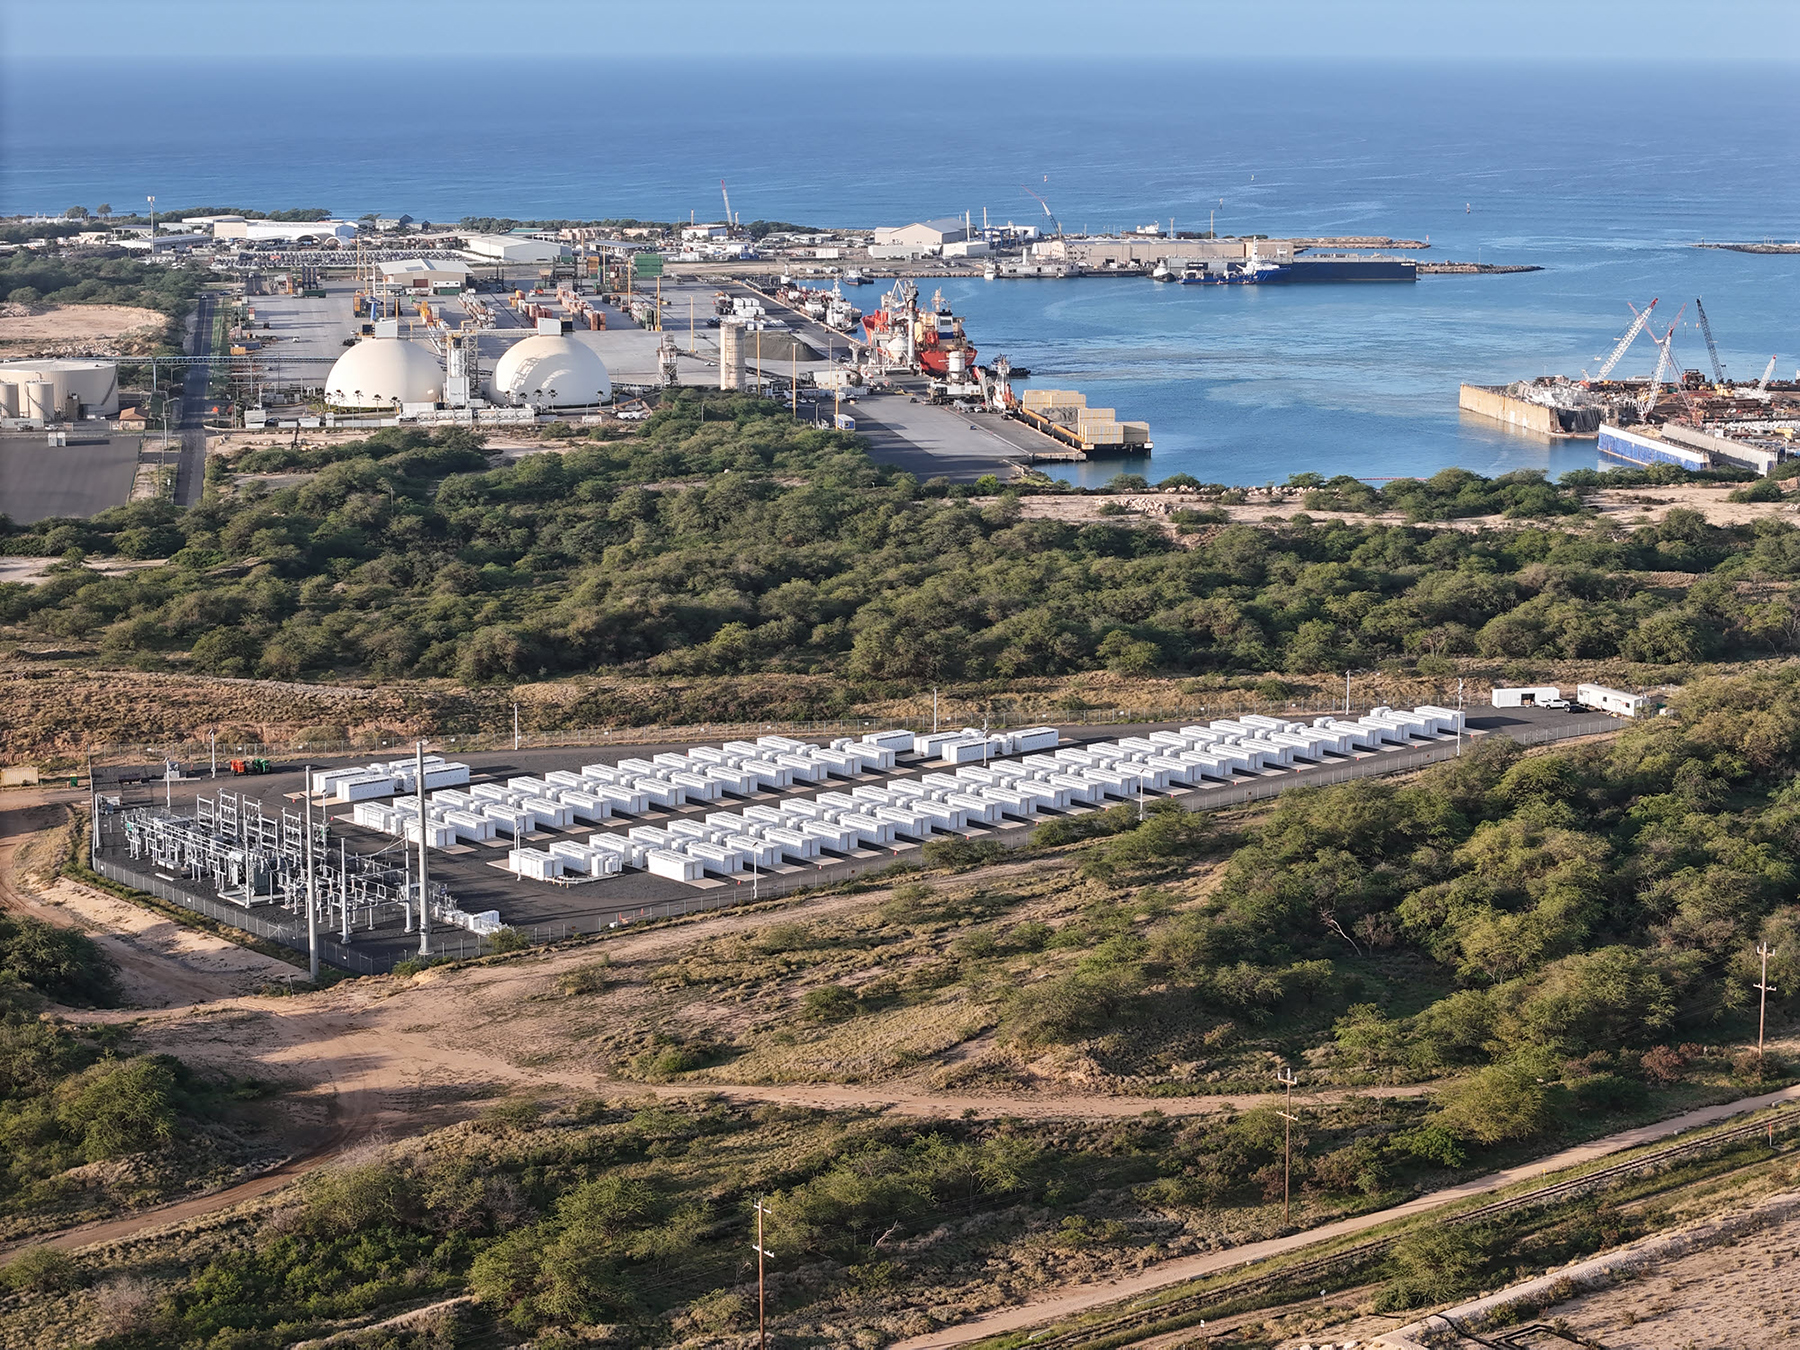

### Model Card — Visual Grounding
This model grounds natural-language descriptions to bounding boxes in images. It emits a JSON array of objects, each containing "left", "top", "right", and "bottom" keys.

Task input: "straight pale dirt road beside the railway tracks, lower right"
[{"left": 891, "top": 1085, "right": 1800, "bottom": 1350}]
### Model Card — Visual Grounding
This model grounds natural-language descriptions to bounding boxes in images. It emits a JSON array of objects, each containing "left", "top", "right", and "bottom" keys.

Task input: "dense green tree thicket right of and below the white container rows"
[{"left": 964, "top": 668, "right": 1800, "bottom": 1130}]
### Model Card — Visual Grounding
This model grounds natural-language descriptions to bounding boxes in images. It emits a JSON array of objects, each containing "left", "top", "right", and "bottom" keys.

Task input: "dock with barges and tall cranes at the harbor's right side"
[{"left": 1458, "top": 299, "right": 1800, "bottom": 475}]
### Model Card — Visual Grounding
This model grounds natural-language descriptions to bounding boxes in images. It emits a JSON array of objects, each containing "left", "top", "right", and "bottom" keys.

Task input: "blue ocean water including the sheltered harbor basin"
[{"left": 0, "top": 62, "right": 1800, "bottom": 482}]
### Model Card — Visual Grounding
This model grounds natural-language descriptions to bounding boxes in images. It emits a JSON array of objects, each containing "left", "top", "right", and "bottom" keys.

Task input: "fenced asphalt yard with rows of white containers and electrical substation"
[{"left": 77, "top": 698, "right": 1633, "bottom": 972}]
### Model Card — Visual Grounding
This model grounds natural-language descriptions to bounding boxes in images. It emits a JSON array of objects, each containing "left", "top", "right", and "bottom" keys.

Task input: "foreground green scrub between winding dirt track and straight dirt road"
[{"left": 10, "top": 1100, "right": 1533, "bottom": 1350}]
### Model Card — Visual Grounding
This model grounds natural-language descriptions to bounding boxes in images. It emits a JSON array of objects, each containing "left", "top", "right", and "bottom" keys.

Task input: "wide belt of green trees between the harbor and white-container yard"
[{"left": 0, "top": 398, "right": 1800, "bottom": 688}]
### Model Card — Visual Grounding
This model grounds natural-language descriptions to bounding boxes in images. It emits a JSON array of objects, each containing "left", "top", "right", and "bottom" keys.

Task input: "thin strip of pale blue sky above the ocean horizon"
[{"left": 10, "top": 0, "right": 1800, "bottom": 60}]
